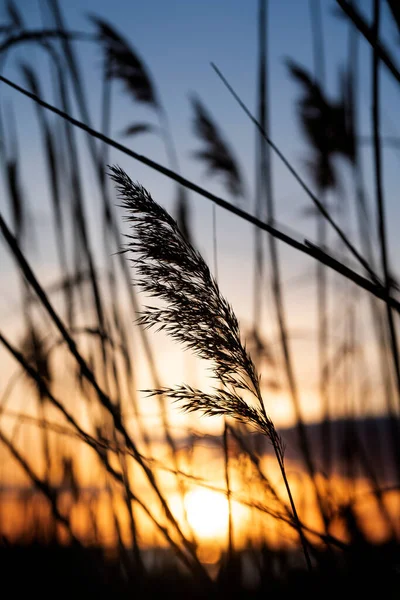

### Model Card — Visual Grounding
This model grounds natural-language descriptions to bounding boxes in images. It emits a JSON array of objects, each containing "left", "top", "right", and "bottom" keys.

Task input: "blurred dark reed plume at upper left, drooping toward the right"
[{"left": 91, "top": 17, "right": 159, "bottom": 108}]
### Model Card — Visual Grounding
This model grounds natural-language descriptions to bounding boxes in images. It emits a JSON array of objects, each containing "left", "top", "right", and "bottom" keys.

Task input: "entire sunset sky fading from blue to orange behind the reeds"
[{"left": 0, "top": 0, "right": 400, "bottom": 564}]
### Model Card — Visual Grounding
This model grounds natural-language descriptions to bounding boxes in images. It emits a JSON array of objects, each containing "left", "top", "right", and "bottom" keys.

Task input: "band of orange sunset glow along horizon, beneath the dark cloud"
[{"left": 0, "top": 452, "right": 400, "bottom": 564}]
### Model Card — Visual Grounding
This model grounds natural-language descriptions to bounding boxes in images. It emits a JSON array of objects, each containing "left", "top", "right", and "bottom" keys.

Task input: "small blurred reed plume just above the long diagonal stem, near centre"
[{"left": 191, "top": 96, "right": 244, "bottom": 197}]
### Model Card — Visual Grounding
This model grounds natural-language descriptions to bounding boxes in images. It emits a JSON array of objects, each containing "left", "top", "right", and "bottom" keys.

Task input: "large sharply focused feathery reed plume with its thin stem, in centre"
[{"left": 110, "top": 166, "right": 311, "bottom": 568}]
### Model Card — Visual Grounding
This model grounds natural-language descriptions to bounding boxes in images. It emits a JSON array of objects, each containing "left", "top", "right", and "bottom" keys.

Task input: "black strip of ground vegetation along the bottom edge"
[{"left": 0, "top": 543, "right": 400, "bottom": 600}]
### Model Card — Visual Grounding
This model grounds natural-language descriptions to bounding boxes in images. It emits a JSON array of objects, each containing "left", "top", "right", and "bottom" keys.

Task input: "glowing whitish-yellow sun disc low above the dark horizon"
[{"left": 185, "top": 490, "right": 229, "bottom": 539}]
